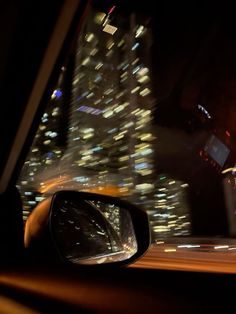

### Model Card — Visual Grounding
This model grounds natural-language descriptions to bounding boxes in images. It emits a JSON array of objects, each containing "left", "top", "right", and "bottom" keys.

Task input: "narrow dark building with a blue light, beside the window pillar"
[{"left": 18, "top": 68, "right": 68, "bottom": 219}]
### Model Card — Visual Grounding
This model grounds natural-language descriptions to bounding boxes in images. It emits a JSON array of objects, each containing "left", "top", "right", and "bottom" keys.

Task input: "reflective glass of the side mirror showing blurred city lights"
[{"left": 51, "top": 197, "right": 137, "bottom": 264}]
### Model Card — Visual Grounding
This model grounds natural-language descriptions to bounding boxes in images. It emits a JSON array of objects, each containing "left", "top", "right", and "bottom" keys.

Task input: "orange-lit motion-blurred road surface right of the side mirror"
[{"left": 132, "top": 239, "right": 236, "bottom": 273}]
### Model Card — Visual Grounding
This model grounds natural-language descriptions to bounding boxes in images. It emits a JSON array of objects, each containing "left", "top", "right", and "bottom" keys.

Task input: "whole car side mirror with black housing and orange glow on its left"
[{"left": 25, "top": 191, "right": 150, "bottom": 264}]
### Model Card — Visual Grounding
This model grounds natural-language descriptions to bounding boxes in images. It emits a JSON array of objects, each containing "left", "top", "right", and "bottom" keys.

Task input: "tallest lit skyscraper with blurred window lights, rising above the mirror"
[{"left": 61, "top": 6, "right": 154, "bottom": 204}]
